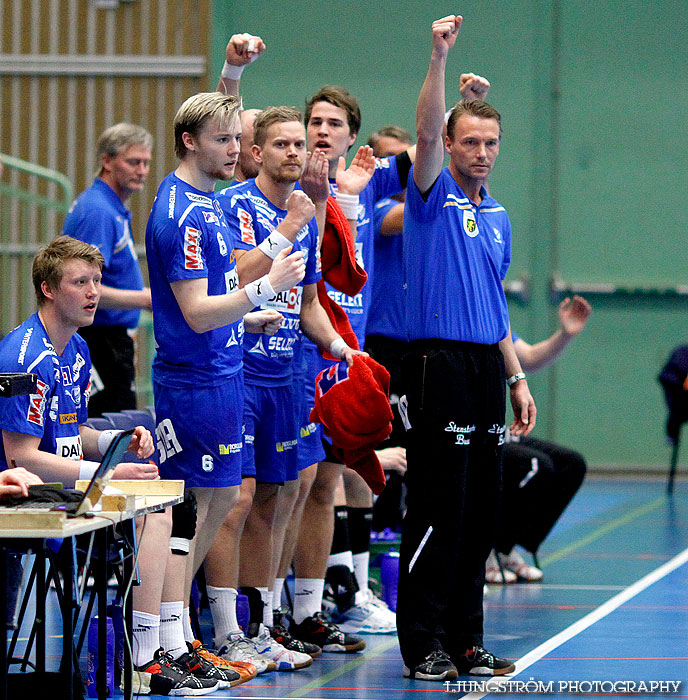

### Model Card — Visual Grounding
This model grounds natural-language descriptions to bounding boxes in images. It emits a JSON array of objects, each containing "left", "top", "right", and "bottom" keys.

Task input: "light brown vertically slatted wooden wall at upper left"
[{"left": 0, "top": 0, "right": 210, "bottom": 333}]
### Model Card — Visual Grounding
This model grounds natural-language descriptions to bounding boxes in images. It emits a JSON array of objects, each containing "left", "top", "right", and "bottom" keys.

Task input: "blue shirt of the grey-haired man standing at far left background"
[{"left": 62, "top": 178, "right": 143, "bottom": 328}]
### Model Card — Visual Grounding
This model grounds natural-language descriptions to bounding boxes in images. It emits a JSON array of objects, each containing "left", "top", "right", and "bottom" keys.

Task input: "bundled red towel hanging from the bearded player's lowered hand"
[{"left": 310, "top": 355, "right": 393, "bottom": 493}]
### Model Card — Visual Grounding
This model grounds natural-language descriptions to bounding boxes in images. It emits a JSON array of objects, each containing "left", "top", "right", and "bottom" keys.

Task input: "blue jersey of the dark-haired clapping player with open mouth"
[{"left": 326, "top": 158, "right": 403, "bottom": 347}]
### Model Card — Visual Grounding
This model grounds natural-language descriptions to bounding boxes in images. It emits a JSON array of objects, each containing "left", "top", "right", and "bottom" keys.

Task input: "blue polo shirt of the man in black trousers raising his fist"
[{"left": 403, "top": 168, "right": 511, "bottom": 345}]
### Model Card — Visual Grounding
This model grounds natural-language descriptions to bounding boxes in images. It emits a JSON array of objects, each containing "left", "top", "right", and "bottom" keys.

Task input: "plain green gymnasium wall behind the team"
[{"left": 211, "top": 0, "right": 688, "bottom": 471}]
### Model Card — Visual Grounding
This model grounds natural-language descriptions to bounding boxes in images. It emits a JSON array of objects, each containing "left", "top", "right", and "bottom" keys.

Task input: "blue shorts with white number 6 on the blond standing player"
[{"left": 153, "top": 372, "right": 244, "bottom": 488}]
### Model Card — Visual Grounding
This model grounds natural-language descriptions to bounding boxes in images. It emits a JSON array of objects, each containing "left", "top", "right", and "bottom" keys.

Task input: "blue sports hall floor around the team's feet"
[{"left": 6, "top": 477, "right": 688, "bottom": 700}]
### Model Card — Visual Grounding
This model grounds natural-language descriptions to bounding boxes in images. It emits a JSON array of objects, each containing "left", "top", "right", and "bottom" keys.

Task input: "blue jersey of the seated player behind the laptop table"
[{"left": 0, "top": 312, "right": 91, "bottom": 469}]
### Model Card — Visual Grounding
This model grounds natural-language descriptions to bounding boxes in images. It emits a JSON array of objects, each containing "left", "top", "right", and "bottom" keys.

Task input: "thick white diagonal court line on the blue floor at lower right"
[{"left": 463, "top": 549, "right": 688, "bottom": 700}]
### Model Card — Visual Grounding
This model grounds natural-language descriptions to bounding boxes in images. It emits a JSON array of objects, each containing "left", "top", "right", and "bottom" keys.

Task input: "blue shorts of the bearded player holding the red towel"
[{"left": 241, "top": 384, "right": 299, "bottom": 484}]
